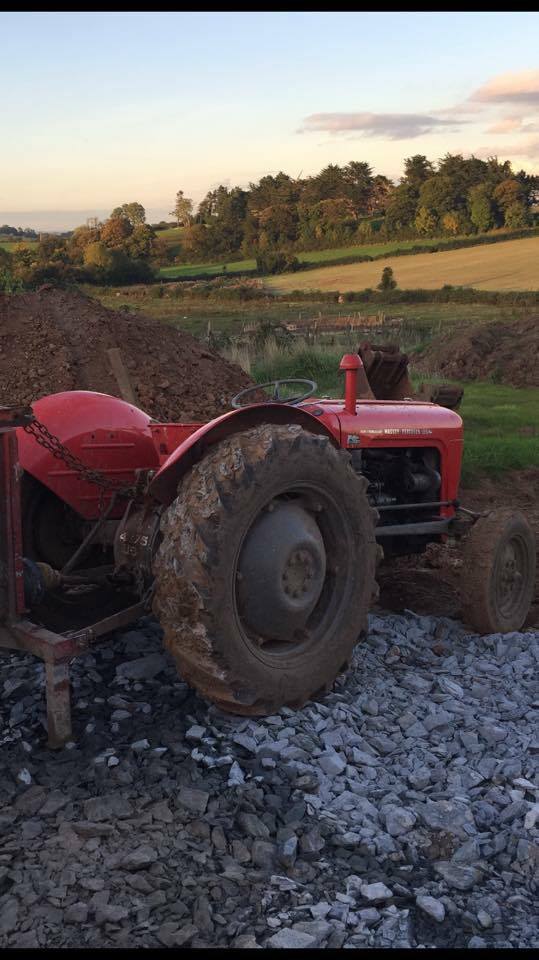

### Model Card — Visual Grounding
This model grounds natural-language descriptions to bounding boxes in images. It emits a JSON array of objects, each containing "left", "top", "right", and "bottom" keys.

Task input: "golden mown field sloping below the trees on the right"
[{"left": 265, "top": 237, "right": 539, "bottom": 293}]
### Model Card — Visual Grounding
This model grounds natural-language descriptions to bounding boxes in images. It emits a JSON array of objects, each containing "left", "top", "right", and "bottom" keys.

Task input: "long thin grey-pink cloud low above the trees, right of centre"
[{"left": 298, "top": 113, "right": 460, "bottom": 140}]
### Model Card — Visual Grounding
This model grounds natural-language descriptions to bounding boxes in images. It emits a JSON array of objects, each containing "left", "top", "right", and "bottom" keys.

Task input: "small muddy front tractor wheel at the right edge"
[{"left": 461, "top": 509, "right": 536, "bottom": 634}]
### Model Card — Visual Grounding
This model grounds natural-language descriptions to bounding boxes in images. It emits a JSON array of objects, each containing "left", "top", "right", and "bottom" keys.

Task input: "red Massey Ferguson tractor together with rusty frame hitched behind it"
[{"left": 0, "top": 354, "right": 535, "bottom": 746}]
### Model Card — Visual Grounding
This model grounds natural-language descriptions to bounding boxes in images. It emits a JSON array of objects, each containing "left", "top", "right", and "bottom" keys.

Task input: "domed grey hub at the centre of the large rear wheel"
[{"left": 237, "top": 501, "right": 326, "bottom": 643}]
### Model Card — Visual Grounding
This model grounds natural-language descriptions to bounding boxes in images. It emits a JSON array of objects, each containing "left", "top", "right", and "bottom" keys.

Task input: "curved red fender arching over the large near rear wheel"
[{"left": 150, "top": 403, "right": 340, "bottom": 506}]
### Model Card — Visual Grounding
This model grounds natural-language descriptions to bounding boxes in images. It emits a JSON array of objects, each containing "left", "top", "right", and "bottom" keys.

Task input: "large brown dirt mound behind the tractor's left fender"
[{"left": 0, "top": 286, "right": 252, "bottom": 421}]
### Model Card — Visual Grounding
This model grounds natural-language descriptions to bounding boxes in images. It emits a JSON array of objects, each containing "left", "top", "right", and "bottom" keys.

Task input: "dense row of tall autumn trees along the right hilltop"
[{"left": 173, "top": 154, "right": 539, "bottom": 261}]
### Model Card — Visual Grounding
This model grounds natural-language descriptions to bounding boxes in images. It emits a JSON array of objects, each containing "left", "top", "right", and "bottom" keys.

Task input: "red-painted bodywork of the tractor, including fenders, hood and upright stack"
[{"left": 17, "top": 376, "right": 463, "bottom": 519}]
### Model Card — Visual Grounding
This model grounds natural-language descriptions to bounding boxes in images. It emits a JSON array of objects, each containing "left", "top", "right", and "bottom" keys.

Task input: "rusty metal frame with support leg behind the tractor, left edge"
[{"left": 0, "top": 407, "right": 148, "bottom": 748}]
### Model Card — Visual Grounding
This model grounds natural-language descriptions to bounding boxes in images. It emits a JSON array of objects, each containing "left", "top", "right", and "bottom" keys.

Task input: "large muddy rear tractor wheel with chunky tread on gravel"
[{"left": 154, "top": 424, "right": 377, "bottom": 716}]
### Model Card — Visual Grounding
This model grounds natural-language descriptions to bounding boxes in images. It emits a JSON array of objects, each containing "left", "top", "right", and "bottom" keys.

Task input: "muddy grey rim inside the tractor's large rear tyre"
[{"left": 233, "top": 484, "right": 352, "bottom": 667}]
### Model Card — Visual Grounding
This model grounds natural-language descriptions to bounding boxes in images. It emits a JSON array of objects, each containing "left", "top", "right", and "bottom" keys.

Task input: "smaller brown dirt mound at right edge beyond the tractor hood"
[{"left": 412, "top": 317, "right": 539, "bottom": 387}]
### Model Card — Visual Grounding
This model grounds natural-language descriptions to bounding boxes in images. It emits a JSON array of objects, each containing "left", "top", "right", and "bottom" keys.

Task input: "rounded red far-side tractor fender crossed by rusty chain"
[{"left": 17, "top": 390, "right": 159, "bottom": 520}]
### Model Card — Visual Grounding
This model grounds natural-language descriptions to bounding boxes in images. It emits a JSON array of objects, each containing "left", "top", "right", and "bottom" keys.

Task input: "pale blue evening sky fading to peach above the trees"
[{"left": 0, "top": 12, "right": 539, "bottom": 230}]
